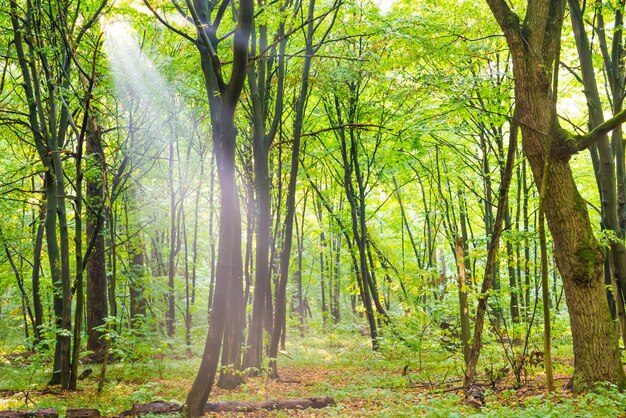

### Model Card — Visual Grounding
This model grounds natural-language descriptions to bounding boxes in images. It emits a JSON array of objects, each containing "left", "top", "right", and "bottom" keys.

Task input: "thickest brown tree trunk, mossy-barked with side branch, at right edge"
[{"left": 486, "top": 0, "right": 626, "bottom": 390}]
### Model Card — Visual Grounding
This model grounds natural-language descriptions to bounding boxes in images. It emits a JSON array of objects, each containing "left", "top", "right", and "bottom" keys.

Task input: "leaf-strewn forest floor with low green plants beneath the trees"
[{"left": 0, "top": 335, "right": 626, "bottom": 417}]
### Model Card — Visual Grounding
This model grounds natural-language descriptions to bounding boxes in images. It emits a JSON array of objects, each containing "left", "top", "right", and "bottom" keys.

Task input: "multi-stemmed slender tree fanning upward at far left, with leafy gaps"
[{"left": 9, "top": 0, "right": 107, "bottom": 388}]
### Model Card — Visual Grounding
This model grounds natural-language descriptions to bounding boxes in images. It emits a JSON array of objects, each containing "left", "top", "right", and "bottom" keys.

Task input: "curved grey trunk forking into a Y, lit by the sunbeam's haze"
[{"left": 185, "top": 0, "right": 254, "bottom": 417}]
